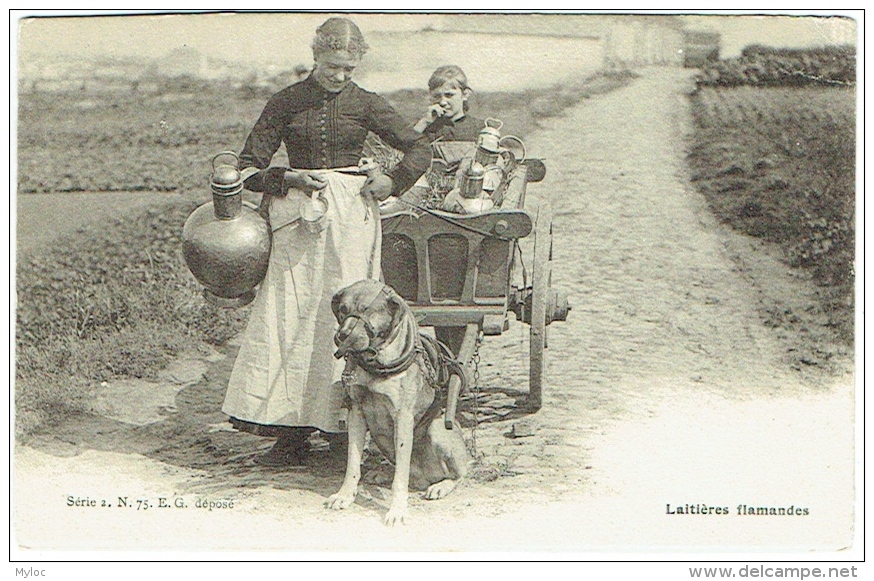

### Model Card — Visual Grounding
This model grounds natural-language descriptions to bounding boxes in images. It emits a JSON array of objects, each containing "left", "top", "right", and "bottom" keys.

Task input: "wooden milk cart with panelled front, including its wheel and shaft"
[{"left": 382, "top": 160, "right": 570, "bottom": 429}]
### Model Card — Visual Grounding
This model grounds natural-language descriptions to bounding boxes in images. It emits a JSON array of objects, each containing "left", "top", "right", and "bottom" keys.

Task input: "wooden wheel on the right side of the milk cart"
[{"left": 528, "top": 203, "right": 552, "bottom": 411}]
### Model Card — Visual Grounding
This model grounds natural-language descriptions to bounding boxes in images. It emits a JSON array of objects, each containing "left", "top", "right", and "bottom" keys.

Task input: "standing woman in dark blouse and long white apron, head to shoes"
[{"left": 222, "top": 18, "right": 431, "bottom": 465}]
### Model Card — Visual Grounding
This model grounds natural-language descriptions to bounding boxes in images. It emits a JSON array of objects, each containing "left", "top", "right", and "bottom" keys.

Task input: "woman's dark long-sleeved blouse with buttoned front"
[{"left": 240, "top": 76, "right": 431, "bottom": 195}]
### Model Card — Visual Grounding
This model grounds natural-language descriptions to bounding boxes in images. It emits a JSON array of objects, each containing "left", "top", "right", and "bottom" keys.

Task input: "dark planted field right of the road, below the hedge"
[{"left": 689, "top": 86, "right": 856, "bottom": 342}]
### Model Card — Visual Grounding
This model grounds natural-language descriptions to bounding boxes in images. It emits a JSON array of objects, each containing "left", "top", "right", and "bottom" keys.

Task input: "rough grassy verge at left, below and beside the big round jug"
[{"left": 15, "top": 196, "right": 246, "bottom": 437}]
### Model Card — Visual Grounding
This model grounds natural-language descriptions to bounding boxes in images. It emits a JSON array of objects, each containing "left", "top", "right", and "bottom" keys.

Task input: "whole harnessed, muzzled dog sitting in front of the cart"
[{"left": 325, "top": 280, "right": 470, "bottom": 526}]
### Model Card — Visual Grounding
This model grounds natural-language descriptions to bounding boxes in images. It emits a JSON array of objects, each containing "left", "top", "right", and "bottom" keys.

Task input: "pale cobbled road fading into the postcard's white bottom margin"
[{"left": 16, "top": 68, "right": 854, "bottom": 552}]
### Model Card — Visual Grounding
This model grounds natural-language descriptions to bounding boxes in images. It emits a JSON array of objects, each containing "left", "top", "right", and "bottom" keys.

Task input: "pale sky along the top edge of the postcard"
[{"left": 12, "top": 13, "right": 856, "bottom": 62}]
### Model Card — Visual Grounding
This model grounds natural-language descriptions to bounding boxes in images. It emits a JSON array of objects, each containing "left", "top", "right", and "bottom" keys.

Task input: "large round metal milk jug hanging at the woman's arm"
[{"left": 182, "top": 151, "right": 271, "bottom": 307}]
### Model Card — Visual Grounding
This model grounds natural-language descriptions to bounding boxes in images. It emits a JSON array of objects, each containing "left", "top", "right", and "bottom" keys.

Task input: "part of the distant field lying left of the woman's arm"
[{"left": 18, "top": 92, "right": 264, "bottom": 193}]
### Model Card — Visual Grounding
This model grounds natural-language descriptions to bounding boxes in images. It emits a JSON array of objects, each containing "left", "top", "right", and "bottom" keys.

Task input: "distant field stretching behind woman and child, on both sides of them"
[{"left": 18, "top": 73, "right": 631, "bottom": 194}]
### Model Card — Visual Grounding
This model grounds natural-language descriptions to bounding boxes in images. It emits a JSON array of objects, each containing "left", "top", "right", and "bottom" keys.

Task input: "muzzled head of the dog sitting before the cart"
[{"left": 331, "top": 279, "right": 407, "bottom": 359}]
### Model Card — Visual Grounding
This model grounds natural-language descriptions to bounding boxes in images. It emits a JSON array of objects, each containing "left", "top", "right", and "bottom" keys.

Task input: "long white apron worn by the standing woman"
[{"left": 222, "top": 170, "right": 382, "bottom": 432}]
